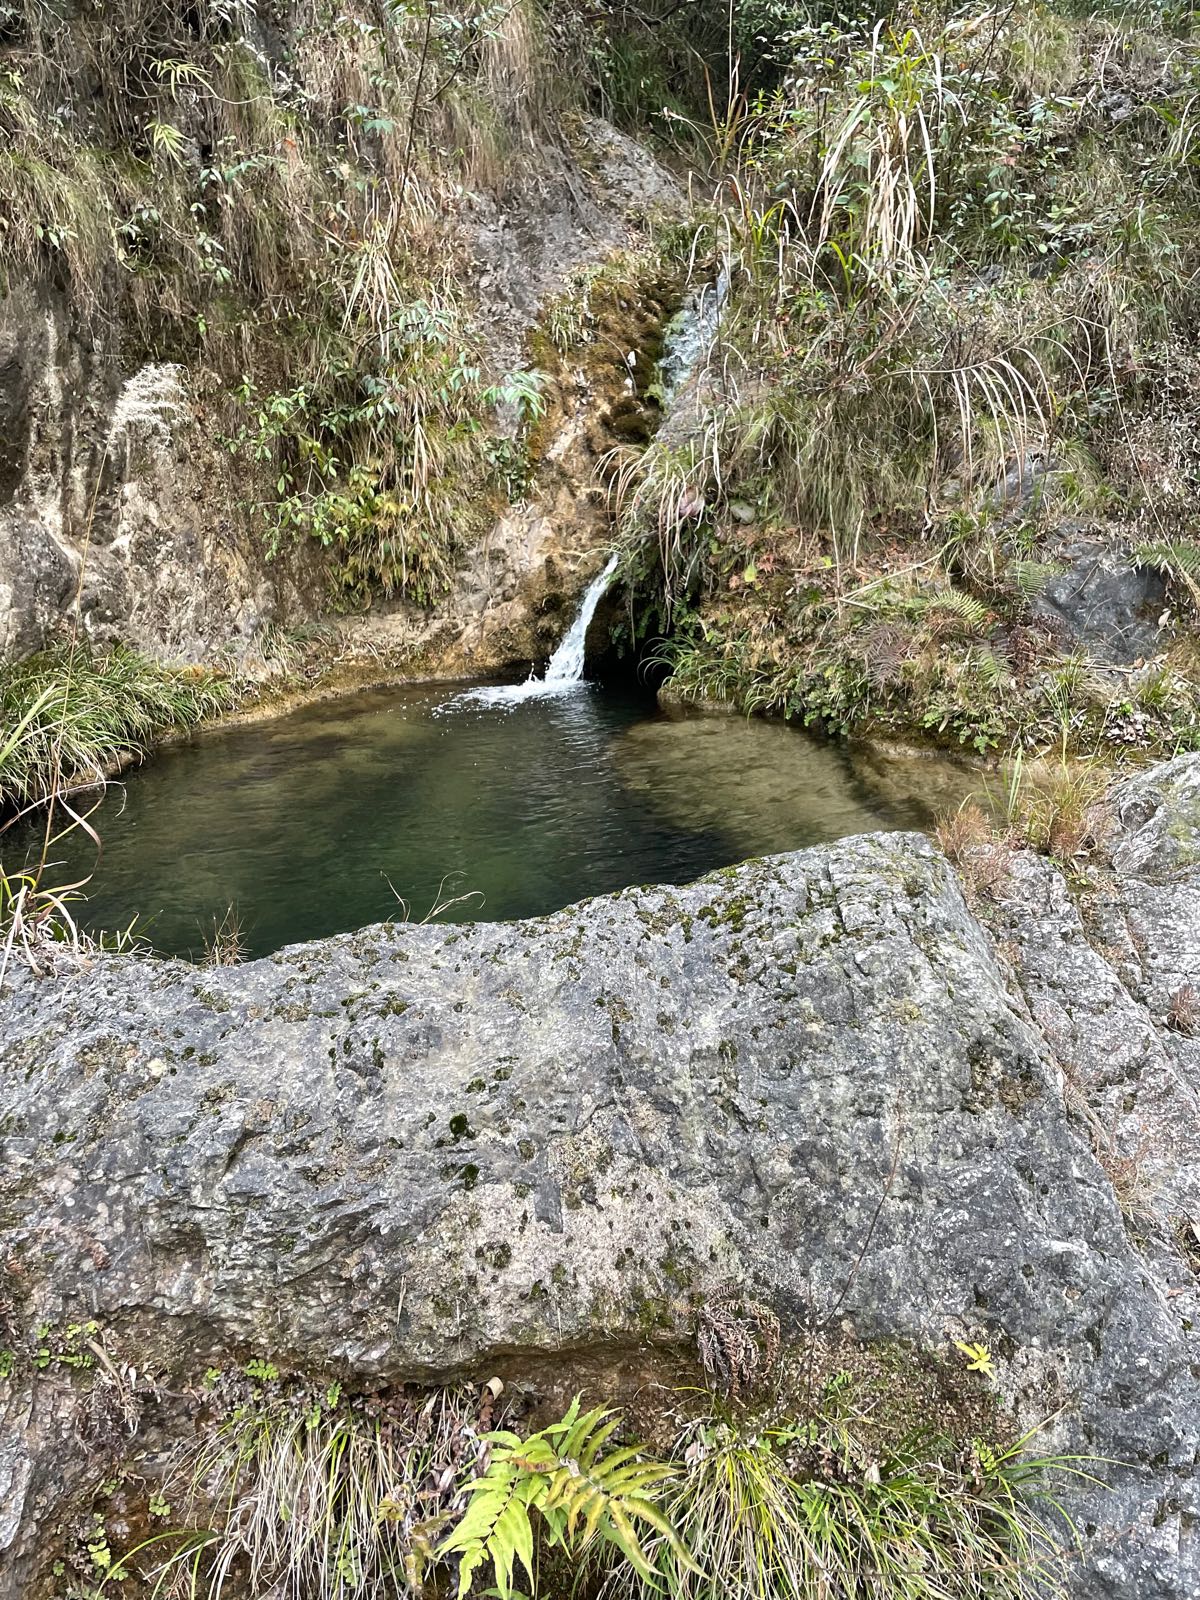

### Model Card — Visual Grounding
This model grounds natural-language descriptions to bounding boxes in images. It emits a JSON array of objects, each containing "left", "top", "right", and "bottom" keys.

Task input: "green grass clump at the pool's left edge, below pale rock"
[{"left": 0, "top": 646, "right": 235, "bottom": 811}]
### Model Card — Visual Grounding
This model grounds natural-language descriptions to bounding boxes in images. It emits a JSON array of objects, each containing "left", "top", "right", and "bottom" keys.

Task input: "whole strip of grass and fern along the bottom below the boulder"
[{"left": 112, "top": 1346, "right": 1096, "bottom": 1600}]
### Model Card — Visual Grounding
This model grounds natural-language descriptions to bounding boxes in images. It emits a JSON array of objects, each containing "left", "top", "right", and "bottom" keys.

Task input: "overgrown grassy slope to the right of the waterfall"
[{"left": 619, "top": 0, "right": 1200, "bottom": 752}]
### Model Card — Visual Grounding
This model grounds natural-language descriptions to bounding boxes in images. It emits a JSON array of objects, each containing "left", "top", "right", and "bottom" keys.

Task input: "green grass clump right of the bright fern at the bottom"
[{"left": 642, "top": 1374, "right": 1086, "bottom": 1600}]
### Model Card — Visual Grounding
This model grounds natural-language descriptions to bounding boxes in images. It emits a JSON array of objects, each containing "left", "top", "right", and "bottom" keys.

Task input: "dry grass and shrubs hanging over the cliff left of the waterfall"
[{"left": 0, "top": 0, "right": 649, "bottom": 605}]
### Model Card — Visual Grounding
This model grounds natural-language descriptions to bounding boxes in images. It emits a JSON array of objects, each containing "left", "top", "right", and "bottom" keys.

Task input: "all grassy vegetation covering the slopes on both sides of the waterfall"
[{"left": 0, "top": 0, "right": 1200, "bottom": 768}]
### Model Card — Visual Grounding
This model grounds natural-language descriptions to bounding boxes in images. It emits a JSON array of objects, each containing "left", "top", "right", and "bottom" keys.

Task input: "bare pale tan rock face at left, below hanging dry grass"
[{"left": 0, "top": 293, "right": 323, "bottom": 661}]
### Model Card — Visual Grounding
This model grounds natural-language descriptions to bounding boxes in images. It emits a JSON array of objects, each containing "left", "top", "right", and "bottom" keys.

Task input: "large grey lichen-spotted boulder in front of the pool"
[{"left": 0, "top": 835, "right": 1200, "bottom": 1600}]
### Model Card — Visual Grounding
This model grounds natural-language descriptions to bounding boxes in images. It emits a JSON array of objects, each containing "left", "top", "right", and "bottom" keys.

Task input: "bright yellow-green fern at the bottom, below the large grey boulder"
[{"left": 438, "top": 1395, "right": 699, "bottom": 1600}]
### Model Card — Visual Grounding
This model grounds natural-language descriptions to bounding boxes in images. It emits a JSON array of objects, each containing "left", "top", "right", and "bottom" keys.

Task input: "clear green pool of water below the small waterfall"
[{"left": 18, "top": 685, "right": 973, "bottom": 955}]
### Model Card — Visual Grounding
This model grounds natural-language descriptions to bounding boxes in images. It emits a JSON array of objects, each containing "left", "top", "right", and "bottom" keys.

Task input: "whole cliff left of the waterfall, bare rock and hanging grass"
[{"left": 0, "top": 0, "right": 680, "bottom": 670}]
